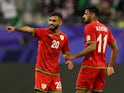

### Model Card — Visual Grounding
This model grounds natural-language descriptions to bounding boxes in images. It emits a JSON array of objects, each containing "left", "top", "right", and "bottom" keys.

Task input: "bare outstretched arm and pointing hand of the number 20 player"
[{"left": 5, "top": 26, "right": 33, "bottom": 33}]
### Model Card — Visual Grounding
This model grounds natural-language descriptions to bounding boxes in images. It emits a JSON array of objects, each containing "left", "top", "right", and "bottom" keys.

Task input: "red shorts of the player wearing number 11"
[{"left": 76, "top": 68, "right": 106, "bottom": 91}]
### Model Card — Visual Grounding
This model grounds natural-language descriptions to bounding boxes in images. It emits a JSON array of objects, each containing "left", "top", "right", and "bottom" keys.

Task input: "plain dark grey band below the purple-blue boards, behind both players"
[{"left": 0, "top": 64, "right": 124, "bottom": 93}]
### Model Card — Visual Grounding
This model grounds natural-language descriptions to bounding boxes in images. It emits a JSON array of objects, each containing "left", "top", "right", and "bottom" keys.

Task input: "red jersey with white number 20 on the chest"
[{"left": 34, "top": 28, "right": 69, "bottom": 74}]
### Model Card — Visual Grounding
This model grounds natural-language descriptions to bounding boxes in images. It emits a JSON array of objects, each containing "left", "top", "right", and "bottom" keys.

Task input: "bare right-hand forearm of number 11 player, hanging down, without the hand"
[{"left": 108, "top": 48, "right": 118, "bottom": 67}]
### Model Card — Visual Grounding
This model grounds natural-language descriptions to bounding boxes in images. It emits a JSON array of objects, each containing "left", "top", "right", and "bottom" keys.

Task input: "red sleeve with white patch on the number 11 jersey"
[{"left": 84, "top": 25, "right": 96, "bottom": 44}]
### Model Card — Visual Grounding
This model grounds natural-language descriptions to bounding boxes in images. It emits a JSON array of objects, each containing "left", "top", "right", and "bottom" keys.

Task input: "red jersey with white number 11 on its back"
[{"left": 83, "top": 21, "right": 115, "bottom": 67}]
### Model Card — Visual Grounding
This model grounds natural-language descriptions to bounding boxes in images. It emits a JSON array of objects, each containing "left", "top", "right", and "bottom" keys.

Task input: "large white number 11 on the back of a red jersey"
[{"left": 97, "top": 34, "right": 107, "bottom": 53}]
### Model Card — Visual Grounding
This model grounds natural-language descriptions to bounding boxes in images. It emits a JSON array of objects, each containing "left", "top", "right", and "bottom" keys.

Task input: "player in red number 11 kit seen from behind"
[{"left": 67, "top": 6, "right": 118, "bottom": 93}]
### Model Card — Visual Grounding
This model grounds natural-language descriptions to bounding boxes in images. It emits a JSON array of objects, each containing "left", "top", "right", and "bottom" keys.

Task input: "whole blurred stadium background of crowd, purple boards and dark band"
[{"left": 0, "top": 0, "right": 124, "bottom": 93}]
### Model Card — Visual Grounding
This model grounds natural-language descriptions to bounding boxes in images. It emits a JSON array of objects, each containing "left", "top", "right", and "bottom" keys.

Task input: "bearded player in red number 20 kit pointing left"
[{"left": 5, "top": 12, "right": 73, "bottom": 93}]
